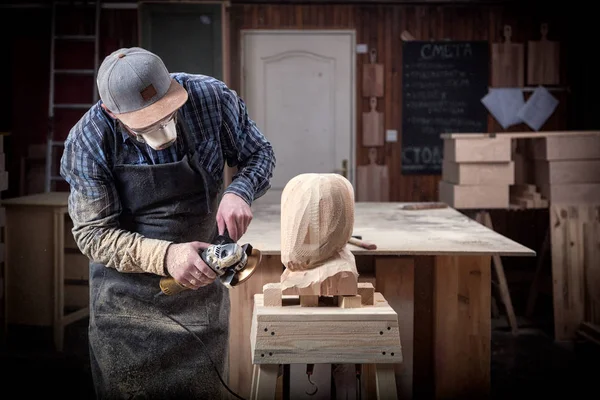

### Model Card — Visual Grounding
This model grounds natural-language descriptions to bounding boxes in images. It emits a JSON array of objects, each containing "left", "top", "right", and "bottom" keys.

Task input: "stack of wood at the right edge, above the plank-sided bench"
[{"left": 531, "top": 132, "right": 600, "bottom": 204}]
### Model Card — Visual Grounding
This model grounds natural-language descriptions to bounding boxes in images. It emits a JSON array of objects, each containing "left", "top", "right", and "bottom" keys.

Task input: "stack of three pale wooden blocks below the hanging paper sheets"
[{"left": 439, "top": 134, "right": 515, "bottom": 209}]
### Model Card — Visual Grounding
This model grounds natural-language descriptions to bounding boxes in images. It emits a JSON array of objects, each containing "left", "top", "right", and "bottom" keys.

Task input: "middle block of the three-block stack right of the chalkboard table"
[{"left": 442, "top": 160, "right": 515, "bottom": 185}]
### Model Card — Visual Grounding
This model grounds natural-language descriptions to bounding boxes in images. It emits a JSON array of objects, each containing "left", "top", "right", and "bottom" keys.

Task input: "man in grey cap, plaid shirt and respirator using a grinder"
[{"left": 61, "top": 48, "right": 275, "bottom": 399}]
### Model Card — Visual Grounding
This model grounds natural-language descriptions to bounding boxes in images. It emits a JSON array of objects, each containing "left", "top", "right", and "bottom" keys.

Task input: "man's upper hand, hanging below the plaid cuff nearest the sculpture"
[{"left": 217, "top": 193, "right": 252, "bottom": 242}]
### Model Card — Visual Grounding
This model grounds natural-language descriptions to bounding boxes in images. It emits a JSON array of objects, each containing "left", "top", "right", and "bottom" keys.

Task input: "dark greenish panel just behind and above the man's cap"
[{"left": 139, "top": 3, "right": 223, "bottom": 80}]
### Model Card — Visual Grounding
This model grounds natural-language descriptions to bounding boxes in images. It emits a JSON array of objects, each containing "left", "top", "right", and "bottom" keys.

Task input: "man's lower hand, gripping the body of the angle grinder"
[{"left": 165, "top": 242, "right": 217, "bottom": 290}]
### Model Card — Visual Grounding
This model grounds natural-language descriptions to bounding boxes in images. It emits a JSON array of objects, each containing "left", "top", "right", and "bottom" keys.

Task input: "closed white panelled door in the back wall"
[{"left": 242, "top": 30, "right": 355, "bottom": 203}]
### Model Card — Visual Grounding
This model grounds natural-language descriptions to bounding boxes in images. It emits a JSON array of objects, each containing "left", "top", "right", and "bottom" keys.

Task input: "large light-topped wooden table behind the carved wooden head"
[{"left": 229, "top": 202, "right": 535, "bottom": 398}]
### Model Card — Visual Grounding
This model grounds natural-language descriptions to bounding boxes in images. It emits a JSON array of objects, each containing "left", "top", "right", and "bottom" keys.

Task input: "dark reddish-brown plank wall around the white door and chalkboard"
[{"left": 230, "top": 4, "right": 567, "bottom": 201}]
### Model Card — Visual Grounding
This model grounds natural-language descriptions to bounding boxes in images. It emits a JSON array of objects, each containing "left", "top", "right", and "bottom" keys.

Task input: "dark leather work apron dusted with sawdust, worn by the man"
[{"left": 89, "top": 119, "right": 230, "bottom": 399}]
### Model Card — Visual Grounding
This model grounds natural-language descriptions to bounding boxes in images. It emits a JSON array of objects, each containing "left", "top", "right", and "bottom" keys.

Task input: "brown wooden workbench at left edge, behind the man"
[{"left": 1, "top": 192, "right": 89, "bottom": 351}]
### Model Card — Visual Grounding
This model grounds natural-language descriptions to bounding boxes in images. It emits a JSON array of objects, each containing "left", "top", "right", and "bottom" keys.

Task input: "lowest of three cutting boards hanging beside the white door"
[{"left": 356, "top": 147, "right": 390, "bottom": 201}]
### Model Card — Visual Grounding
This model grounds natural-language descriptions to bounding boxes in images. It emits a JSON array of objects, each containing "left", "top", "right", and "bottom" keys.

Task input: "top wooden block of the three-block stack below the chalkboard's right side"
[{"left": 444, "top": 136, "right": 512, "bottom": 162}]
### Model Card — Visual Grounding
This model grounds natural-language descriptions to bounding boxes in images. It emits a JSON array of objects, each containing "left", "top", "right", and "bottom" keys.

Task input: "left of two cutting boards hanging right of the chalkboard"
[{"left": 492, "top": 25, "right": 525, "bottom": 88}]
